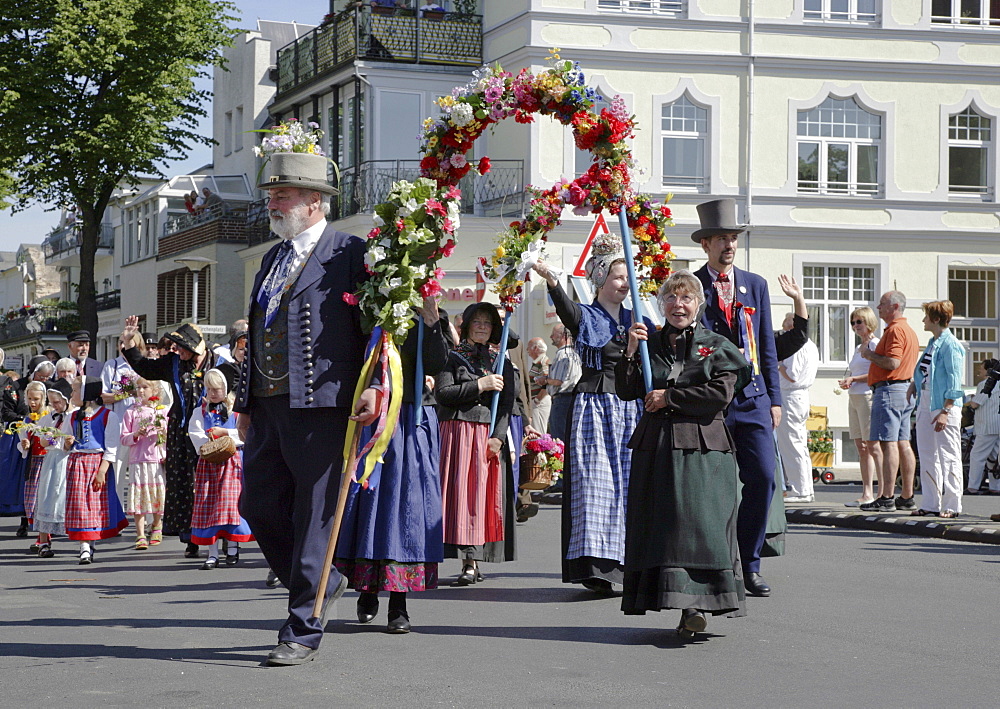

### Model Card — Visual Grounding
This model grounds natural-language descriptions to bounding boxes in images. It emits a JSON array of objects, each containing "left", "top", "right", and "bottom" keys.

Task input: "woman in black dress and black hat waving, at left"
[{"left": 122, "top": 315, "right": 213, "bottom": 559}]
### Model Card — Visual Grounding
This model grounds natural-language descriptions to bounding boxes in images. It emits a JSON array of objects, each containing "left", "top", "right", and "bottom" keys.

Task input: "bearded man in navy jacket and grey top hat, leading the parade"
[{"left": 234, "top": 153, "right": 378, "bottom": 665}]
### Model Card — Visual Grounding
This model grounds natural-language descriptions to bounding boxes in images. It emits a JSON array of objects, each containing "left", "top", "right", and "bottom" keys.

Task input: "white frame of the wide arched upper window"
[{"left": 793, "top": 95, "right": 886, "bottom": 197}]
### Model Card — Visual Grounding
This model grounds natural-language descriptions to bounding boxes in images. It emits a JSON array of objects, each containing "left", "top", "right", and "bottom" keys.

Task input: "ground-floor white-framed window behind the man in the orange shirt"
[{"left": 802, "top": 266, "right": 876, "bottom": 363}]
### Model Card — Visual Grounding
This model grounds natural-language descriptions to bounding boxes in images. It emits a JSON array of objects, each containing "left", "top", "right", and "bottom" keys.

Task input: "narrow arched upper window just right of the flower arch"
[{"left": 660, "top": 94, "right": 708, "bottom": 192}]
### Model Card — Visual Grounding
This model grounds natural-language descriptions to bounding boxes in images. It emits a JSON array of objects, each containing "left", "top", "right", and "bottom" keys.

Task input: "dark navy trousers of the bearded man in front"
[{"left": 240, "top": 395, "right": 349, "bottom": 648}]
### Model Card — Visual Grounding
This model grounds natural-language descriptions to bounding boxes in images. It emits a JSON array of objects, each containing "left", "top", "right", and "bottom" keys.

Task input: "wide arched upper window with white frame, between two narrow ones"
[{"left": 797, "top": 96, "right": 882, "bottom": 196}]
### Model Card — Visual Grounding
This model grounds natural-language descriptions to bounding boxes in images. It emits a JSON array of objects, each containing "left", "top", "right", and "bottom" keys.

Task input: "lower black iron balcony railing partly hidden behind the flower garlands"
[{"left": 333, "top": 160, "right": 524, "bottom": 218}]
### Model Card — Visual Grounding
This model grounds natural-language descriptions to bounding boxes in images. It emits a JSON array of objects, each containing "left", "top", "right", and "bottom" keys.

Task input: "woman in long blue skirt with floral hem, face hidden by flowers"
[{"left": 336, "top": 296, "right": 452, "bottom": 633}]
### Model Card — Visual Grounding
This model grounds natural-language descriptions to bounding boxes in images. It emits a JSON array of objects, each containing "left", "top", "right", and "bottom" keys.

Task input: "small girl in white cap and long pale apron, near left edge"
[{"left": 32, "top": 379, "right": 75, "bottom": 559}]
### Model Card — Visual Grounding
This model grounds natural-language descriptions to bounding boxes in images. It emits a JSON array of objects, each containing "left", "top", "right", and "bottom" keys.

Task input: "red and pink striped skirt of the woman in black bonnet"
[{"left": 441, "top": 421, "right": 503, "bottom": 546}]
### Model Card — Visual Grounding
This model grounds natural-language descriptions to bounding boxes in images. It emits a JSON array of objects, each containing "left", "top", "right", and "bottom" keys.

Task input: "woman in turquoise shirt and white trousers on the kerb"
[{"left": 906, "top": 300, "right": 965, "bottom": 518}]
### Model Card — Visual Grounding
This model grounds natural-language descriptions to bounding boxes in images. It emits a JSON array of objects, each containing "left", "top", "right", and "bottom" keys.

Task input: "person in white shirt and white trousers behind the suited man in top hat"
[{"left": 777, "top": 306, "right": 819, "bottom": 502}]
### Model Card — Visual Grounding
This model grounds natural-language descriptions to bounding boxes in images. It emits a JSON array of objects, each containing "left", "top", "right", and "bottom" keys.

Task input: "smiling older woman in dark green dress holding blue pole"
[{"left": 615, "top": 271, "right": 751, "bottom": 637}]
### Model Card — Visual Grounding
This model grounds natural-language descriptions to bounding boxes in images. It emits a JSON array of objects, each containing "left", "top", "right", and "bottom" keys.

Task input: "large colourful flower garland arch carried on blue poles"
[{"left": 420, "top": 49, "right": 674, "bottom": 309}]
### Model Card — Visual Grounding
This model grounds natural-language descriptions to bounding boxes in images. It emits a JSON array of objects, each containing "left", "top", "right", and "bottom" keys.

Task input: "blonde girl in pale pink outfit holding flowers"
[{"left": 121, "top": 377, "right": 170, "bottom": 549}]
